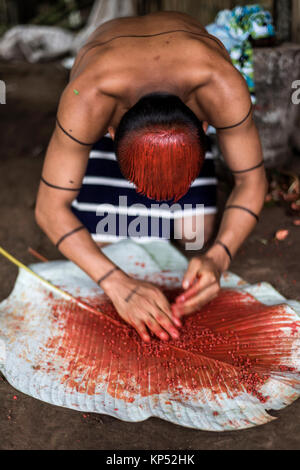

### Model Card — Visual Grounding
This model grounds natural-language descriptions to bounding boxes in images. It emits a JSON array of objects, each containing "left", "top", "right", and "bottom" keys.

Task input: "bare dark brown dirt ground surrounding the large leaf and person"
[{"left": 0, "top": 63, "right": 300, "bottom": 450}]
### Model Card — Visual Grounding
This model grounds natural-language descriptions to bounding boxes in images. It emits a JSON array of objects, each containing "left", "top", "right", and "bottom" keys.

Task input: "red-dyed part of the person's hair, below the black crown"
[{"left": 118, "top": 123, "right": 205, "bottom": 201}]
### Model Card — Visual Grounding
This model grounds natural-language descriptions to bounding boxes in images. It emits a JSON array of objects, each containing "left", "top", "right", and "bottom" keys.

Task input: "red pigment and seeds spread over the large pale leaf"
[{"left": 46, "top": 288, "right": 300, "bottom": 403}]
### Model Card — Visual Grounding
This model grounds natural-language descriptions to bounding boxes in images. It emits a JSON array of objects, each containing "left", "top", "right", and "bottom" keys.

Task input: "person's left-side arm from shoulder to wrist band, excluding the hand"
[{"left": 36, "top": 83, "right": 120, "bottom": 281}]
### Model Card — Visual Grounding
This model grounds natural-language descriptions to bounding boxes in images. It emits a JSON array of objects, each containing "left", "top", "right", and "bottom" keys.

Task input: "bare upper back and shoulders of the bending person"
[{"left": 67, "top": 12, "right": 244, "bottom": 132}]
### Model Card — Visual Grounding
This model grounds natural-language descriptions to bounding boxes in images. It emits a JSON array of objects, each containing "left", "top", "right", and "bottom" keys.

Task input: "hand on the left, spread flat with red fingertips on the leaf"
[{"left": 102, "top": 273, "right": 181, "bottom": 342}]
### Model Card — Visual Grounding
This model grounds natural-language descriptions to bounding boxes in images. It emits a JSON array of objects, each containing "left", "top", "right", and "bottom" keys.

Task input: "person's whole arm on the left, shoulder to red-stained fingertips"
[{"left": 36, "top": 82, "right": 180, "bottom": 341}]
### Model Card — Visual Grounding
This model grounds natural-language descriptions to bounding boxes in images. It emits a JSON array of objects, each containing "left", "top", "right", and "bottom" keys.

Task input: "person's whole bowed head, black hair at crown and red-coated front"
[{"left": 114, "top": 93, "right": 205, "bottom": 201}]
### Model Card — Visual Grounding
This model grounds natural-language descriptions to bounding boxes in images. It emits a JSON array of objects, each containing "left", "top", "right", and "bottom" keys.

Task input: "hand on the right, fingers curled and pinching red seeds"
[{"left": 172, "top": 256, "right": 221, "bottom": 318}]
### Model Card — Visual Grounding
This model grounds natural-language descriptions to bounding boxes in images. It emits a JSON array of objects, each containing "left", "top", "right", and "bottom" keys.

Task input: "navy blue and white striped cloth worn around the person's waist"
[{"left": 72, "top": 134, "right": 217, "bottom": 242}]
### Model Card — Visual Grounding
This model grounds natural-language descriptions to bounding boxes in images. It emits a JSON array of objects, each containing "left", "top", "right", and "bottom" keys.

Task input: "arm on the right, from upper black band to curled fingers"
[{"left": 174, "top": 108, "right": 267, "bottom": 316}]
